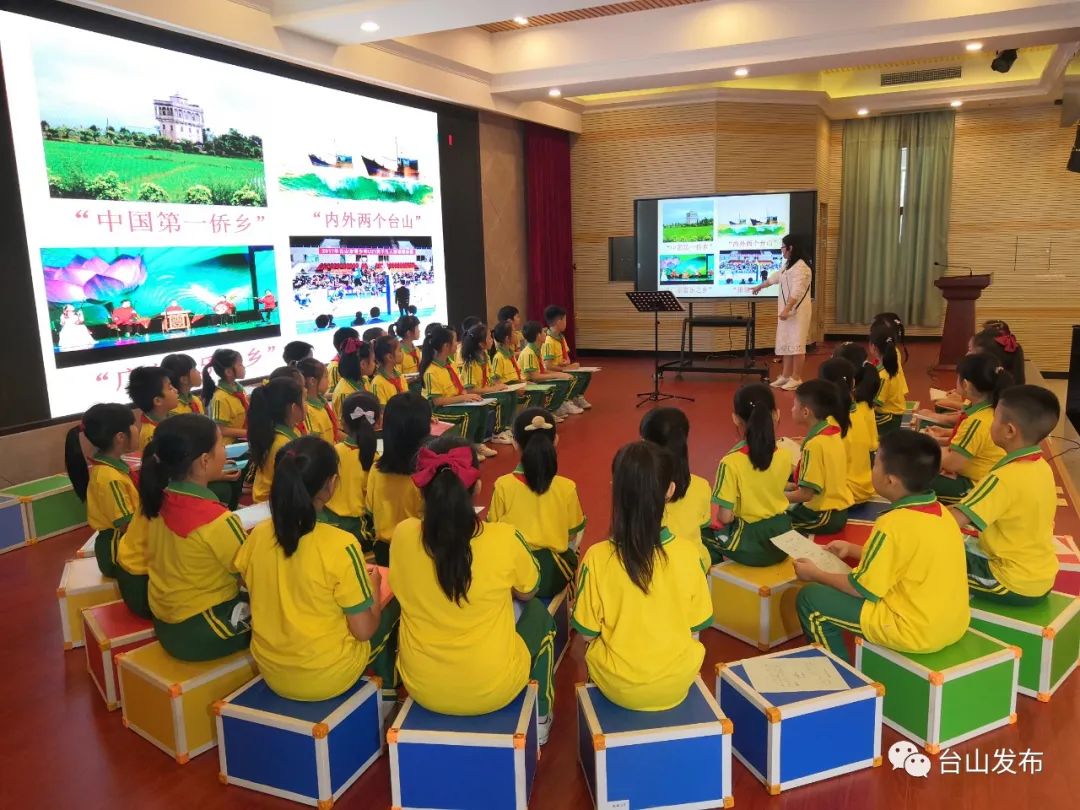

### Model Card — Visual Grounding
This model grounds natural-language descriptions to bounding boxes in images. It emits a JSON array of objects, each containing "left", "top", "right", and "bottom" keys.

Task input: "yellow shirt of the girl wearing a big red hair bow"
[{"left": 390, "top": 519, "right": 540, "bottom": 715}]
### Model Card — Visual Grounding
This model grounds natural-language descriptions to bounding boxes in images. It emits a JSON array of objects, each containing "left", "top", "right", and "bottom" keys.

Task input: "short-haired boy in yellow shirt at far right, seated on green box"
[{"left": 950, "top": 386, "right": 1061, "bottom": 605}]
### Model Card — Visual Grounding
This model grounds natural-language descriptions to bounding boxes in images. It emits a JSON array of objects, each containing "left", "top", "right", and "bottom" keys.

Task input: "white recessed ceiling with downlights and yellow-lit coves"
[{"left": 63, "top": 0, "right": 1080, "bottom": 129}]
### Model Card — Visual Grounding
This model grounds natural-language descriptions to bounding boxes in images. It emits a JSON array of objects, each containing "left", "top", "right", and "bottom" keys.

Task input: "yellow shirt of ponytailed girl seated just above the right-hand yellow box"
[{"left": 713, "top": 442, "right": 792, "bottom": 523}]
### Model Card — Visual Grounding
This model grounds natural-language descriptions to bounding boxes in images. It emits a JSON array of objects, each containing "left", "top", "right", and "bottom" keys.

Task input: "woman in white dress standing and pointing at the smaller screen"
[{"left": 751, "top": 233, "right": 813, "bottom": 391}]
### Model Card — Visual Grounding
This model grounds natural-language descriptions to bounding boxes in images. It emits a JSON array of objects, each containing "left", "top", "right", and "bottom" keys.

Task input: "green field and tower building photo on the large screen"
[{"left": 33, "top": 29, "right": 267, "bottom": 206}]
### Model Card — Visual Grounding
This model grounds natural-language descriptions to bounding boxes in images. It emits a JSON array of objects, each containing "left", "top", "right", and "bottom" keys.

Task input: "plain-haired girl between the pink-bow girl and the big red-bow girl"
[{"left": 364, "top": 391, "right": 431, "bottom": 566}]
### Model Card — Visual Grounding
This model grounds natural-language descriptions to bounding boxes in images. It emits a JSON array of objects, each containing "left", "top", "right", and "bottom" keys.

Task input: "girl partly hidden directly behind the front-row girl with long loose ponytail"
[{"left": 638, "top": 408, "right": 719, "bottom": 572}]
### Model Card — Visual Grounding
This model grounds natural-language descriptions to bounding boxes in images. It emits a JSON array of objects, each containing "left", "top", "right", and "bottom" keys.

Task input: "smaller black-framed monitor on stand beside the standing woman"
[{"left": 634, "top": 191, "right": 818, "bottom": 299}]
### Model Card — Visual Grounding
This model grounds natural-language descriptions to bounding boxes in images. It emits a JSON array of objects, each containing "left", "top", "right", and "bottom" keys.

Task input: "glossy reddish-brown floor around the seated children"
[{"left": 0, "top": 345, "right": 1080, "bottom": 810}]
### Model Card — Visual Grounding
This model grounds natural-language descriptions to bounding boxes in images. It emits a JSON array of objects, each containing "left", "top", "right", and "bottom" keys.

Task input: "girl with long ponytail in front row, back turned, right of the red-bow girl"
[{"left": 570, "top": 442, "right": 713, "bottom": 712}]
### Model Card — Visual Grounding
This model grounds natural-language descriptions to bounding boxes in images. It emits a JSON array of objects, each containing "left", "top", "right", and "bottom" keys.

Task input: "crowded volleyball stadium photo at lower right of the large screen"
[{"left": 289, "top": 237, "right": 442, "bottom": 334}]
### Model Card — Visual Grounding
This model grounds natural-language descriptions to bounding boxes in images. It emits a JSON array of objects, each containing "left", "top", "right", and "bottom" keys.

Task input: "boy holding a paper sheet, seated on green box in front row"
[{"left": 794, "top": 430, "right": 971, "bottom": 659}]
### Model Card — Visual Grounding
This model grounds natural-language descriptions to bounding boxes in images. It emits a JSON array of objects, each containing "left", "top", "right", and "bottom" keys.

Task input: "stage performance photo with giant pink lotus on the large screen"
[{"left": 41, "top": 246, "right": 279, "bottom": 366}]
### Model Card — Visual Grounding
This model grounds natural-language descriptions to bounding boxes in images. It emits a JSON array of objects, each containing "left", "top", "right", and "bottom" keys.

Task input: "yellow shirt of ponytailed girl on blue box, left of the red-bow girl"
[{"left": 234, "top": 521, "right": 378, "bottom": 701}]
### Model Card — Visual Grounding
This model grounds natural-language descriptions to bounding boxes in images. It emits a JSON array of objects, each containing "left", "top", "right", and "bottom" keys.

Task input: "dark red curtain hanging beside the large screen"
[{"left": 525, "top": 123, "right": 575, "bottom": 348}]
